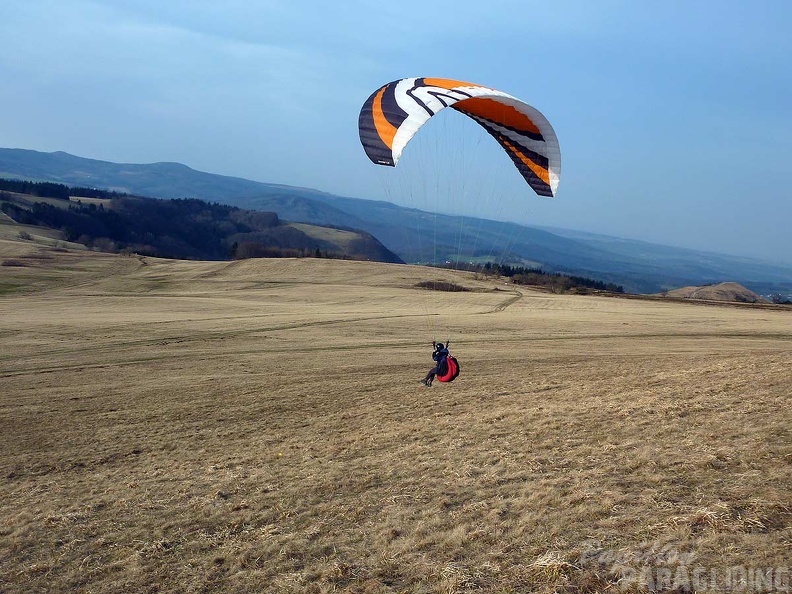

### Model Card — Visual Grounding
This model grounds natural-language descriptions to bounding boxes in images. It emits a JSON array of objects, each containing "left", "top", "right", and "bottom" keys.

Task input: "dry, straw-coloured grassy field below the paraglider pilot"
[{"left": 0, "top": 239, "right": 792, "bottom": 594}]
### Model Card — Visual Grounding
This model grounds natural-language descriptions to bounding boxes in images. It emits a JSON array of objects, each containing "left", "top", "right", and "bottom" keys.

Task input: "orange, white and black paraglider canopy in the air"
[{"left": 358, "top": 78, "right": 561, "bottom": 196}]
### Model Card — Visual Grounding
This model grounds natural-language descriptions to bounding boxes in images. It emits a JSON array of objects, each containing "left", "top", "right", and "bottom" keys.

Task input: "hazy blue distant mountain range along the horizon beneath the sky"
[{"left": 0, "top": 149, "right": 792, "bottom": 295}]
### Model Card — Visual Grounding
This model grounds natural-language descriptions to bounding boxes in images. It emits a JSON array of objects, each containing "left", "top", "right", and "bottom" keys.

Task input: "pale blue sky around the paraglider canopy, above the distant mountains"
[{"left": 0, "top": 0, "right": 792, "bottom": 262}]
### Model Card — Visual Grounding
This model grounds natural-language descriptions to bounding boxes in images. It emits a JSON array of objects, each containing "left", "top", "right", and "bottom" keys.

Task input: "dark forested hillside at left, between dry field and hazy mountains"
[{"left": 0, "top": 180, "right": 400, "bottom": 262}]
